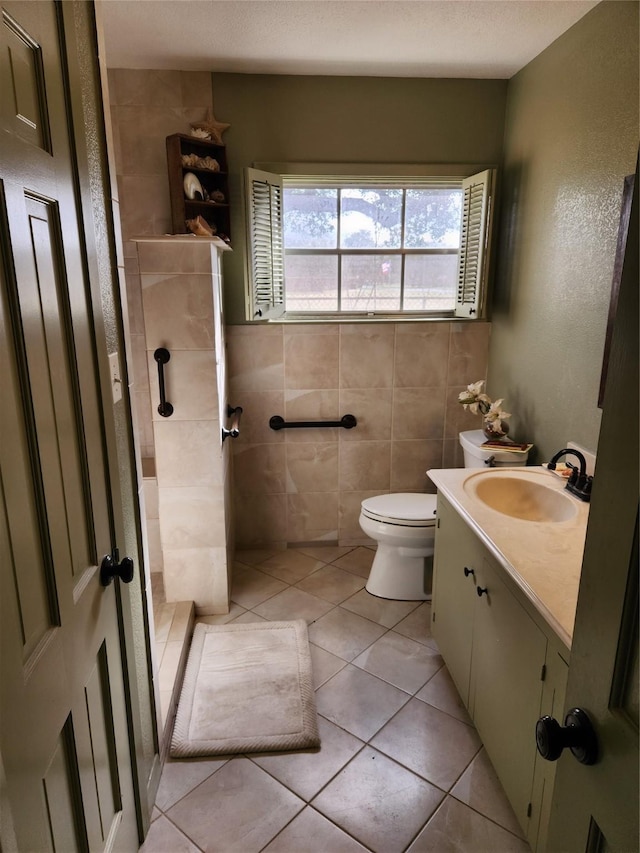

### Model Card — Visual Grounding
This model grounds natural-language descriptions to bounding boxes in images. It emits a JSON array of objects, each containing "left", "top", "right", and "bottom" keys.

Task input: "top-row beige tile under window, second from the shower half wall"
[{"left": 284, "top": 334, "right": 339, "bottom": 389}]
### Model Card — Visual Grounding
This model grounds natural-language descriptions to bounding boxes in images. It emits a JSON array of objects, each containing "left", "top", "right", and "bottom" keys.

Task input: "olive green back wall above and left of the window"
[{"left": 212, "top": 73, "right": 507, "bottom": 323}]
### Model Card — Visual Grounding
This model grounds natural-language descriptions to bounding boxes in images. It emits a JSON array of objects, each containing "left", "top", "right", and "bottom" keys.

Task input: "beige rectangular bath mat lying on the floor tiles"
[{"left": 171, "top": 619, "right": 320, "bottom": 758}]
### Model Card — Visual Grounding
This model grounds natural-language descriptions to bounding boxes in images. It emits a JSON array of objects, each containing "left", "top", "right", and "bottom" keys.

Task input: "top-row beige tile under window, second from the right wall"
[{"left": 393, "top": 323, "right": 449, "bottom": 388}]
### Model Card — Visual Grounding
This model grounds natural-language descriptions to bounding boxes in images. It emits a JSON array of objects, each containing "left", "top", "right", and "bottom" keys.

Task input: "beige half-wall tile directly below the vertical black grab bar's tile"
[{"left": 153, "top": 419, "right": 222, "bottom": 489}]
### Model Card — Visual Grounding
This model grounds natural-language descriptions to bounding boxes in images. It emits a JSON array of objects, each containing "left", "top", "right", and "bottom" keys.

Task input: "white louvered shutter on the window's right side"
[{"left": 455, "top": 169, "right": 495, "bottom": 319}]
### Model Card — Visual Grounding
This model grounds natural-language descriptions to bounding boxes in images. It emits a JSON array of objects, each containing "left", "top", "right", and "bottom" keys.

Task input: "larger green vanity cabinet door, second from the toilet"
[{"left": 470, "top": 559, "right": 547, "bottom": 830}]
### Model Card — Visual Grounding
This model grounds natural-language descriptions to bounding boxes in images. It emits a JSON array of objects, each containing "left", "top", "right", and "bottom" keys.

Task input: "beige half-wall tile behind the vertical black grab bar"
[{"left": 147, "top": 348, "right": 219, "bottom": 423}]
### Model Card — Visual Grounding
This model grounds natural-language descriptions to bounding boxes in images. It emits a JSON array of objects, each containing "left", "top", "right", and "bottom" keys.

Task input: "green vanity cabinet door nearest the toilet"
[{"left": 431, "top": 497, "right": 483, "bottom": 707}]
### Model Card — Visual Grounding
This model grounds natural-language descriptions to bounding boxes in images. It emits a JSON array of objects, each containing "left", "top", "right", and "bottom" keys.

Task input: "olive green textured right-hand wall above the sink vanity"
[{"left": 488, "top": 2, "right": 638, "bottom": 461}]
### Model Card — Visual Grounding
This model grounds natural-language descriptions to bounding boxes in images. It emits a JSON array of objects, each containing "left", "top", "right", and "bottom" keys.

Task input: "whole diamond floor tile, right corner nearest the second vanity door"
[{"left": 371, "top": 699, "right": 481, "bottom": 791}]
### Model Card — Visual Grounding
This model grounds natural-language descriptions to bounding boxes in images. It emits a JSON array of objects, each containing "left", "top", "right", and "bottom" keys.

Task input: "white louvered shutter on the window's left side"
[{"left": 245, "top": 169, "right": 284, "bottom": 320}]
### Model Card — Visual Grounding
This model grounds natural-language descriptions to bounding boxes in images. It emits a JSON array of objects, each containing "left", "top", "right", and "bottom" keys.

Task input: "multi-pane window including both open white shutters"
[{"left": 246, "top": 169, "right": 494, "bottom": 320}]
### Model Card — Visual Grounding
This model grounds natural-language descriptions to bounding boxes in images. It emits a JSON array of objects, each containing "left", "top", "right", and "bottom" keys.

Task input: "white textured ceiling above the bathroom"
[{"left": 101, "top": 0, "right": 597, "bottom": 78}]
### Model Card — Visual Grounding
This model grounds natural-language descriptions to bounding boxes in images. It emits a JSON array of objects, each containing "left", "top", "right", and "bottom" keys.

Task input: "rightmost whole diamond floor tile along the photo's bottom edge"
[{"left": 312, "top": 747, "right": 443, "bottom": 853}]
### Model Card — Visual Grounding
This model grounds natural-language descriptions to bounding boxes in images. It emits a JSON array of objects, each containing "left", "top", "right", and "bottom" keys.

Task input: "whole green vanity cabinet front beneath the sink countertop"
[{"left": 432, "top": 495, "right": 567, "bottom": 850}]
